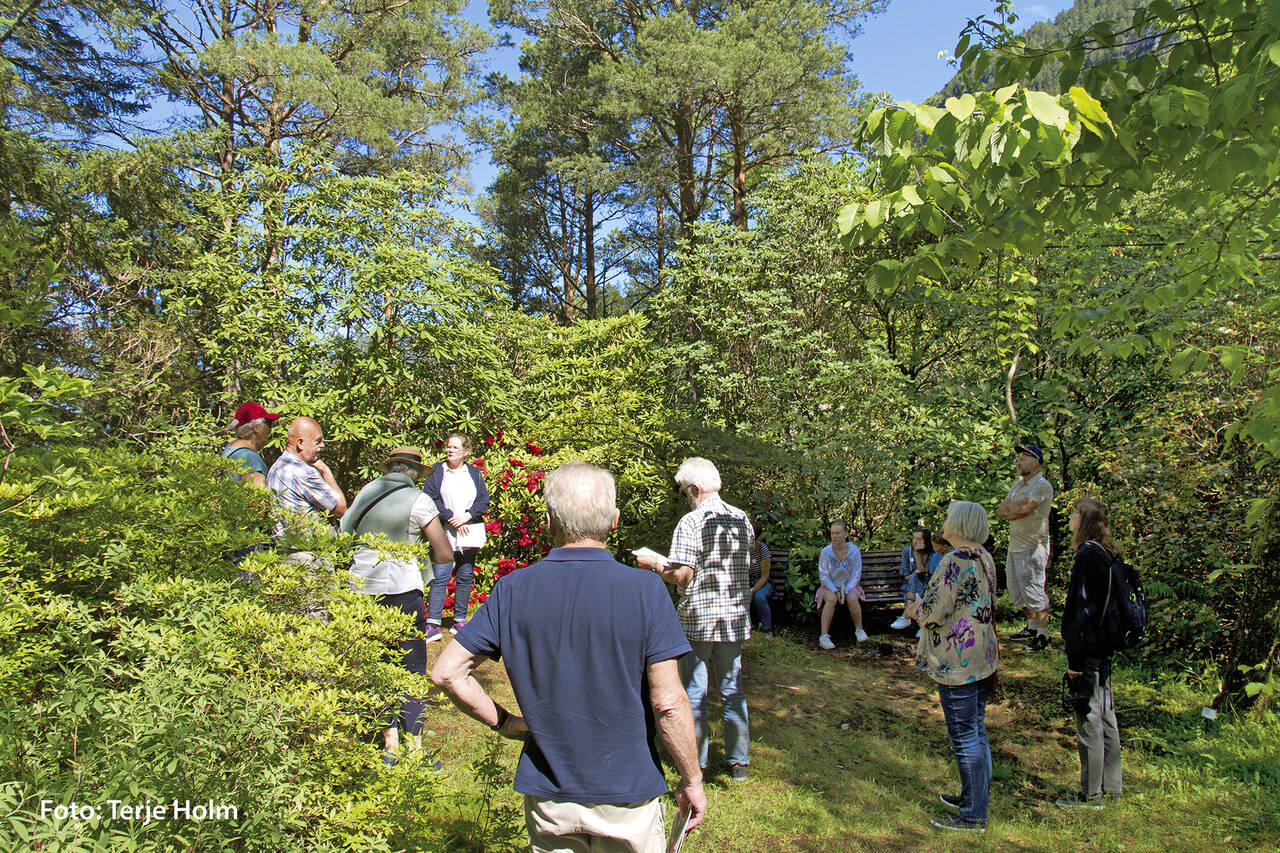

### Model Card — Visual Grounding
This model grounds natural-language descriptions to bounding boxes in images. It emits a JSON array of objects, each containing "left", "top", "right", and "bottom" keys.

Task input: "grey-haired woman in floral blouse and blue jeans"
[{"left": 915, "top": 501, "right": 1000, "bottom": 833}]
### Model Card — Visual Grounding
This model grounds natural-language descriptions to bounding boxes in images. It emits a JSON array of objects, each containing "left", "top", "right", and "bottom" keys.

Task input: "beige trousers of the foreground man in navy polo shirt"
[{"left": 525, "top": 794, "right": 667, "bottom": 853}]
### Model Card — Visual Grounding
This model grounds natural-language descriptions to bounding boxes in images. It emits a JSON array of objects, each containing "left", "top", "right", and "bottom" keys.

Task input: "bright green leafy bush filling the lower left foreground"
[{"left": 0, "top": 447, "right": 519, "bottom": 850}]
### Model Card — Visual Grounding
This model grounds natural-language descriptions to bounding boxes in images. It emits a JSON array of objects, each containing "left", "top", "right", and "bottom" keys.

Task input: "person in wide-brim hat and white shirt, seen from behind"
[{"left": 342, "top": 447, "right": 453, "bottom": 770}]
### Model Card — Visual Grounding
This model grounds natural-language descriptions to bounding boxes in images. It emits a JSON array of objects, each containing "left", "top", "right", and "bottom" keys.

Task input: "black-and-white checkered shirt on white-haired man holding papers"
[{"left": 668, "top": 496, "right": 751, "bottom": 643}]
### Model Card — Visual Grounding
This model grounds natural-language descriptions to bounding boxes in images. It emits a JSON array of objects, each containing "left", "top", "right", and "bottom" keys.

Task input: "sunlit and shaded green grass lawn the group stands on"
[{"left": 414, "top": 614, "right": 1280, "bottom": 852}]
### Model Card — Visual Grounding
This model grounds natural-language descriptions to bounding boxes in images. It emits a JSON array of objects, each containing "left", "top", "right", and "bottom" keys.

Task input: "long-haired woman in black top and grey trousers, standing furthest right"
[{"left": 1056, "top": 497, "right": 1120, "bottom": 808}]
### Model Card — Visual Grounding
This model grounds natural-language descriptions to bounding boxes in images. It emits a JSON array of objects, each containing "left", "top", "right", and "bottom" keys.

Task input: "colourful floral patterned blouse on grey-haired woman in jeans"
[{"left": 915, "top": 548, "right": 1000, "bottom": 686}]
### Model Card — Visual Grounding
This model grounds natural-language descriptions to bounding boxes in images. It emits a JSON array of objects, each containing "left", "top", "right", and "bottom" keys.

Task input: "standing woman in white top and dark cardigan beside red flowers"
[{"left": 422, "top": 433, "right": 489, "bottom": 643}]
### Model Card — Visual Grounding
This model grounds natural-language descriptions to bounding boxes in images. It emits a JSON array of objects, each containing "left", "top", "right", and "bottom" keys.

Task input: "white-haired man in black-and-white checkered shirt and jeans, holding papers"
[{"left": 637, "top": 456, "right": 751, "bottom": 781}]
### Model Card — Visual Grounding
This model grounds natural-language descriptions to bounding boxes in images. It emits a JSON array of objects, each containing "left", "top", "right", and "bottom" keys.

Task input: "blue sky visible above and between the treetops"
[{"left": 467, "top": 0, "right": 1074, "bottom": 191}]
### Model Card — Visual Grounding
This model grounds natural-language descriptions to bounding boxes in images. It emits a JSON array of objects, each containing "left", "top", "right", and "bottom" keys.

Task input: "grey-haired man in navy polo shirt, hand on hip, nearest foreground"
[{"left": 431, "top": 462, "right": 707, "bottom": 853}]
